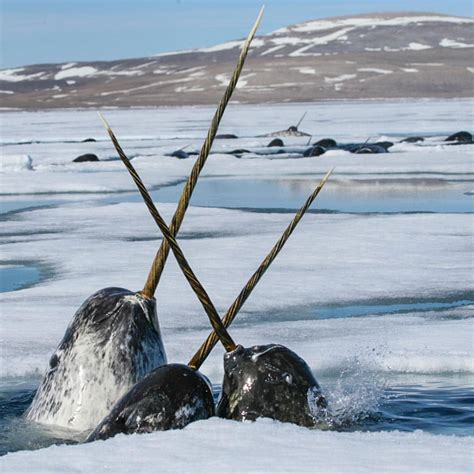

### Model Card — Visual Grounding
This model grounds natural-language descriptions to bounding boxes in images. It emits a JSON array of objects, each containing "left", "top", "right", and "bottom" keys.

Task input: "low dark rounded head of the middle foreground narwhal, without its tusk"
[{"left": 87, "top": 364, "right": 214, "bottom": 441}]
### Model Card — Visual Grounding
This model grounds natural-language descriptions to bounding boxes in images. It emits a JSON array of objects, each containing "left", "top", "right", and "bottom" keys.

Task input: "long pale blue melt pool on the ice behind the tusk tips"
[{"left": 106, "top": 177, "right": 474, "bottom": 213}]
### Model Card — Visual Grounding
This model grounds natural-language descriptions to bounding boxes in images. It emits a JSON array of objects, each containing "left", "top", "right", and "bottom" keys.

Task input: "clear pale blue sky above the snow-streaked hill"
[{"left": 0, "top": 0, "right": 473, "bottom": 68}]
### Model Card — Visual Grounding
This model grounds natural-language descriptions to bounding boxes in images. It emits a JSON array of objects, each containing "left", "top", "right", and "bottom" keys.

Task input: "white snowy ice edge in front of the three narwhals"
[{"left": 0, "top": 418, "right": 472, "bottom": 474}]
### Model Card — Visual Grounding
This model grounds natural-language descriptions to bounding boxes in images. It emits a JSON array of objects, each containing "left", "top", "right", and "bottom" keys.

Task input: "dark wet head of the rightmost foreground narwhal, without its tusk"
[{"left": 217, "top": 344, "right": 327, "bottom": 427}]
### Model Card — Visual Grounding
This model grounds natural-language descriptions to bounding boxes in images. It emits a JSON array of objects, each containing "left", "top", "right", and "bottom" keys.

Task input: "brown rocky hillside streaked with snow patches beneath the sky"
[{"left": 0, "top": 13, "right": 474, "bottom": 109}]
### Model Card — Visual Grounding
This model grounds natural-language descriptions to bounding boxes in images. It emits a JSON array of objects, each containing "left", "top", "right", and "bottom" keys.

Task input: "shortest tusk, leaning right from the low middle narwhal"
[{"left": 189, "top": 168, "right": 334, "bottom": 369}]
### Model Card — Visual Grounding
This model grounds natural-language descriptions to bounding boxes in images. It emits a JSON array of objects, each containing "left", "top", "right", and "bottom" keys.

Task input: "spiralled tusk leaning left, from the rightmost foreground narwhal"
[{"left": 99, "top": 112, "right": 237, "bottom": 352}]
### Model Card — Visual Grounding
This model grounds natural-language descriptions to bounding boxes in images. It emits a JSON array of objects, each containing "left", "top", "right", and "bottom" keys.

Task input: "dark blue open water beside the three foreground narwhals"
[{"left": 0, "top": 377, "right": 474, "bottom": 456}]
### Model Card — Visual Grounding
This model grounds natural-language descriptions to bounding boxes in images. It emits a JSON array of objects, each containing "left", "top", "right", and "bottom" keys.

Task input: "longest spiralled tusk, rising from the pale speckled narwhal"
[{"left": 143, "top": 7, "right": 264, "bottom": 297}]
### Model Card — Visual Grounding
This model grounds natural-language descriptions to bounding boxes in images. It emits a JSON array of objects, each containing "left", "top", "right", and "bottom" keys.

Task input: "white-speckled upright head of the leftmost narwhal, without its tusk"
[{"left": 26, "top": 288, "right": 166, "bottom": 431}]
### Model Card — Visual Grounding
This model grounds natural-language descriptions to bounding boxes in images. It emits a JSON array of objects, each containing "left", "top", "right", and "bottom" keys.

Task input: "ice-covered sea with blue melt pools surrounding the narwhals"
[{"left": 0, "top": 100, "right": 474, "bottom": 473}]
